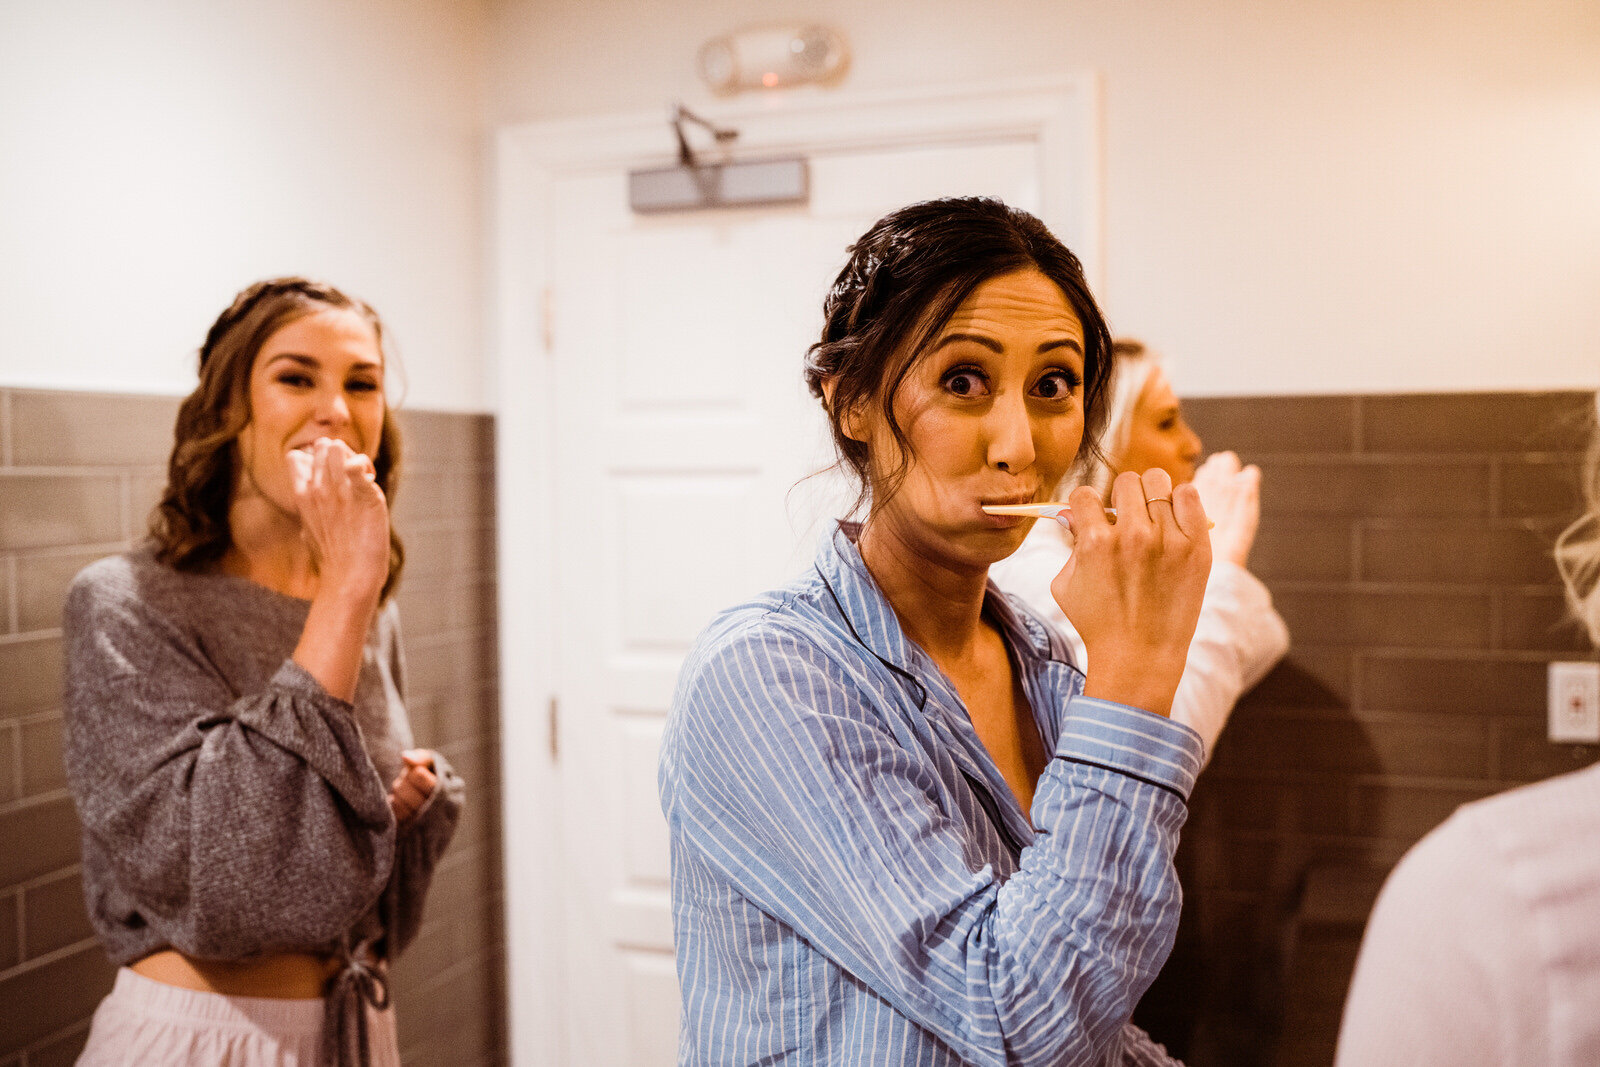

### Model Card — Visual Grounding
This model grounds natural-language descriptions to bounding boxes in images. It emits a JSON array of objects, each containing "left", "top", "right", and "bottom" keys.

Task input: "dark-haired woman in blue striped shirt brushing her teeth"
[{"left": 659, "top": 198, "right": 1211, "bottom": 1067}]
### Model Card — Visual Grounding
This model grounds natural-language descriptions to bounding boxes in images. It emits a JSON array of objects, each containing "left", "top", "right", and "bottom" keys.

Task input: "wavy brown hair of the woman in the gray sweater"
[{"left": 150, "top": 277, "right": 405, "bottom": 600}]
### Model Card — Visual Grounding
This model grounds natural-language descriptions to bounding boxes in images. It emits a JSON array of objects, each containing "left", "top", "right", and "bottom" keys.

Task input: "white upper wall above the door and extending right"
[{"left": 490, "top": 0, "right": 1600, "bottom": 395}]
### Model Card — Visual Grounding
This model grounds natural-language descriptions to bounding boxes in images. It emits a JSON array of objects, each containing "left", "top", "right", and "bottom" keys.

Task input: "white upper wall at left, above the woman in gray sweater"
[{"left": 0, "top": 0, "right": 486, "bottom": 410}]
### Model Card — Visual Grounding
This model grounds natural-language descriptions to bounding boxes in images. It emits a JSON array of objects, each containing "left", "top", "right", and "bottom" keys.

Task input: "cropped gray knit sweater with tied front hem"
[{"left": 66, "top": 549, "right": 464, "bottom": 998}]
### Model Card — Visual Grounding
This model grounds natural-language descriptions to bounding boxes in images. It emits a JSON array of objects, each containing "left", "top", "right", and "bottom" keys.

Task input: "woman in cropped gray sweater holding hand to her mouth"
[{"left": 66, "top": 278, "right": 462, "bottom": 1067}]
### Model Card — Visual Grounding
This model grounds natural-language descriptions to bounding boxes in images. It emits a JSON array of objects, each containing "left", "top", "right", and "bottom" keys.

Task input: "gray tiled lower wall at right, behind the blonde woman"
[{"left": 1164, "top": 392, "right": 1600, "bottom": 1067}]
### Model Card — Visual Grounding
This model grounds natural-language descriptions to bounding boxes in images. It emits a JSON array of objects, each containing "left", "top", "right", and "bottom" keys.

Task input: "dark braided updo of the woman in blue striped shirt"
[{"left": 805, "top": 197, "right": 1112, "bottom": 514}]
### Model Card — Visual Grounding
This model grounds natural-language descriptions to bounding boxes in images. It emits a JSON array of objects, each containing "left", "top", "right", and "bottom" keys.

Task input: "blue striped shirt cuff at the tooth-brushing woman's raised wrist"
[{"left": 1056, "top": 696, "right": 1205, "bottom": 801}]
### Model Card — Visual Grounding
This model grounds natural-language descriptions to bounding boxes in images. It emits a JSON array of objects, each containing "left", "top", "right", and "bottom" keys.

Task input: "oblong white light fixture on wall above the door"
[{"left": 699, "top": 22, "right": 850, "bottom": 94}]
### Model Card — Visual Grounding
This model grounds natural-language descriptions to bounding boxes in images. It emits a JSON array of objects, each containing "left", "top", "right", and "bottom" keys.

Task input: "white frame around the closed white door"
[{"left": 490, "top": 72, "right": 1104, "bottom": 1067}]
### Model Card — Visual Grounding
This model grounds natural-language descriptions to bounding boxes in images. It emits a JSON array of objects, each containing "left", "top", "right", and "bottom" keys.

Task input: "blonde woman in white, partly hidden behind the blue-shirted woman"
[{"left": 989, "top": 339, "right": 1290, "bottom": 761}]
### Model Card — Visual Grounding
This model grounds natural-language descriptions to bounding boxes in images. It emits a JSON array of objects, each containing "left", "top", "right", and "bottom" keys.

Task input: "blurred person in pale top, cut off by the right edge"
[{"left": 1336, "top": 397, "right": 1600, "bottom": 1067}]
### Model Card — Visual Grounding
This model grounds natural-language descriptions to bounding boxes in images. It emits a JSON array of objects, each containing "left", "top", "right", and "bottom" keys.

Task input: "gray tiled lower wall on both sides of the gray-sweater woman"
[{"left": 0, "top": 389, "right": 507, "bottom": 1067}]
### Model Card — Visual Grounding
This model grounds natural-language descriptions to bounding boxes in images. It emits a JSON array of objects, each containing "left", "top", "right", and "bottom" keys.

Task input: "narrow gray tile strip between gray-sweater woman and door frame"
[{"left": 390, "top": 411, "right": 507, "bottom": 1064}]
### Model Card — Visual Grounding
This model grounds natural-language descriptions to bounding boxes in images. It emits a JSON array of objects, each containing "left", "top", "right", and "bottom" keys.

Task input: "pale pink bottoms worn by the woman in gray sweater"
[{"left": 78, "top": 968, "right": 400, "bottom": 1067}]
